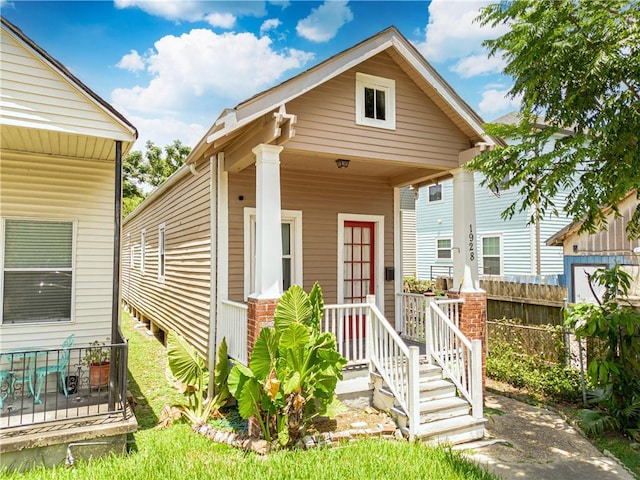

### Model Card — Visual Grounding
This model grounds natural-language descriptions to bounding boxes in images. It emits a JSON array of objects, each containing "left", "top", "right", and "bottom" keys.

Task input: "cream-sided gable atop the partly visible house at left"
[{"left": 0, "top": 17, "right": 138, "bottom": 151}]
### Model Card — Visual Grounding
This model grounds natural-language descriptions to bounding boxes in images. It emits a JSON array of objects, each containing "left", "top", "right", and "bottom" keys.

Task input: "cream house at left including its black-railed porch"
[{"left": 0, "top": 17, "right": 137, "bottom": 469}]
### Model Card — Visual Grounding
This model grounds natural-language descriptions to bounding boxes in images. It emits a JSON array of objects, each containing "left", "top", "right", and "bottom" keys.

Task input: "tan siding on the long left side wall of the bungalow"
[{"left": 122, "top": 162, "right": 211, "bottom": 355}]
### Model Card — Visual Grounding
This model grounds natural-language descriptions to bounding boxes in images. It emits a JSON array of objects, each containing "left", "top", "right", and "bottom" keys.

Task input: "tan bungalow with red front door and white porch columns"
[{"left": 122, "top": 28, "right": 495, "bottom": 441}]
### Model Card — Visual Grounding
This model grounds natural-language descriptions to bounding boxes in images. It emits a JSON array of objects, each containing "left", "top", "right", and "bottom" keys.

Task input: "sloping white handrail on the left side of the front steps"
[{"left": 367, "top": 302, "right": 420, "bottom": 439}]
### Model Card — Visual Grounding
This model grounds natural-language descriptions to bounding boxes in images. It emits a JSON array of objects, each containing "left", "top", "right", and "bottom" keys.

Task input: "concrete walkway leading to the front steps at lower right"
[{"left": 464, "top": 393, "right": 635, "bottom": 480}]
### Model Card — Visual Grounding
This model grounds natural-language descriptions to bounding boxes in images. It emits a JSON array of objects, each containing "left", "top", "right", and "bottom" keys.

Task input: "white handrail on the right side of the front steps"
[{"left": 426, "top": 302, "right": 483, "bottom": 418}]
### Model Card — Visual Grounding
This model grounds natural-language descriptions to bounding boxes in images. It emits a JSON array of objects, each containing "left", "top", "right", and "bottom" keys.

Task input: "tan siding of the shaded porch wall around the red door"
[{"left": 229, "top": 167, "right": 394, "bottom": 321}]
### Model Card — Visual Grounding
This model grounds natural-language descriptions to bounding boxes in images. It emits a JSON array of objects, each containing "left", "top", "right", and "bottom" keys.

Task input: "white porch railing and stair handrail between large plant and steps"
[{"left": 321, "top": 299, "right": 420, "bottom": 438}]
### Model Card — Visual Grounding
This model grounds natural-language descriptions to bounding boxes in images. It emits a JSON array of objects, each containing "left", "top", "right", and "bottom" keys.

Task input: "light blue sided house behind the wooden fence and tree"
[{"left": 416, "top": 113, "right": 570, "bottom": 284}]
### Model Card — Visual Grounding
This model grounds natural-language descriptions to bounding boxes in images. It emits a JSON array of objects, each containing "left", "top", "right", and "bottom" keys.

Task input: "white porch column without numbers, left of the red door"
[{"left": 250, "top": 143, "right": 283, "bottom": 299}]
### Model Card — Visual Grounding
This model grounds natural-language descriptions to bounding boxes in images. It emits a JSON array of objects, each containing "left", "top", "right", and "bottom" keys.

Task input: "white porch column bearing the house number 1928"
[{"left": 452, "top": 159, "right": 480, "bottom": 292}]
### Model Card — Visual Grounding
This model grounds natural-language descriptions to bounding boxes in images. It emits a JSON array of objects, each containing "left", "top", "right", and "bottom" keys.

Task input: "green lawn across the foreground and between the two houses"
[{"left": 5, "top": 315, "right": 496, "bottom": 480}]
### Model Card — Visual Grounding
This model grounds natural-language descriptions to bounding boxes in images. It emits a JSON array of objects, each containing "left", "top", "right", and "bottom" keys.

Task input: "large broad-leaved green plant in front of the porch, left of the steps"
[{"left": 229, "top": 283, "right": 347, "bottom": 446}]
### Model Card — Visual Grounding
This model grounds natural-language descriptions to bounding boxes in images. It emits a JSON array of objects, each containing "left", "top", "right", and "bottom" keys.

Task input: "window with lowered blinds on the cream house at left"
[{"left": 2, "top": 219, "right": 75, "bottom": 325}]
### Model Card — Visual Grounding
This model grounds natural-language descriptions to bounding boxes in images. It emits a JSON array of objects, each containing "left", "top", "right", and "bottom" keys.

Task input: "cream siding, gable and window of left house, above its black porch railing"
[{"left": 0, "top": 18, "right": 137, "bottom": 364}]
